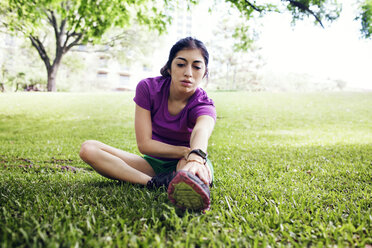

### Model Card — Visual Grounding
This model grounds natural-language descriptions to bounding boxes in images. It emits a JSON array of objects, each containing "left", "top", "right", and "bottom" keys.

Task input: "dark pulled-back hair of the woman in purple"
[{"left": 160, "top": 37, "right": 209, "bottom": 77}]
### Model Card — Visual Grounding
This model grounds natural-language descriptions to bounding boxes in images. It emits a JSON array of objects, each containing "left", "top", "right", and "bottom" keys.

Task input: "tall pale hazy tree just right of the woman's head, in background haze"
[{"left": 207, "top": 6, "right": 264, "bottom": 91}]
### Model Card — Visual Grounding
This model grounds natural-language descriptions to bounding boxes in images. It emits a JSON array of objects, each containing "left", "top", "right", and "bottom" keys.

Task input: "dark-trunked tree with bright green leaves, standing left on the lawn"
[{"left": 0, "top": 0, "right": 170, "bottom": 91}]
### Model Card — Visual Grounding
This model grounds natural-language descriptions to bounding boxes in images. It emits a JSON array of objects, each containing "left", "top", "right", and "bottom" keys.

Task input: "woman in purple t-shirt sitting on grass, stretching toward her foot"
[{"left": 80, "top": 37, "right": 216, "bottom": 210}]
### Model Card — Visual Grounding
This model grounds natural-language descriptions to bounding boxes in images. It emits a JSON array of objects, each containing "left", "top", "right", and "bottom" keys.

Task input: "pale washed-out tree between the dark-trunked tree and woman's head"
[{"left": 58, "top": 24, "right": 165, "bottom": 91}]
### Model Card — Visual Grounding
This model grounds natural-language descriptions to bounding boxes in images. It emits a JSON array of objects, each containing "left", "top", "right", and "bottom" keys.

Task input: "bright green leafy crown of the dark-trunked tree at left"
[{"left": 2, "top": 0, "right": 169, "bottom": 44}]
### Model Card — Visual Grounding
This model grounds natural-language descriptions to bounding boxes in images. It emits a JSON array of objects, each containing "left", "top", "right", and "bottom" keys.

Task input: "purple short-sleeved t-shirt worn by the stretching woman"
[{"left": 133, "top": 76, "right": 216, "bottom": 147}]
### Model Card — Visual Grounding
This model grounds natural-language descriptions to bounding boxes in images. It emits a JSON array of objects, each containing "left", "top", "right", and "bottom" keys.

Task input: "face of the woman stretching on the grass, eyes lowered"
[{"left": 169, "top": 49, "right": 206, "bottom": 93}]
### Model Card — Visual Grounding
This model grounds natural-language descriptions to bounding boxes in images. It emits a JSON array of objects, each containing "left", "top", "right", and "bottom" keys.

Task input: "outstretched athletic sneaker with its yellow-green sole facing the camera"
[{"left": 168, "top": 170, "right": 211, "bottom": 210}]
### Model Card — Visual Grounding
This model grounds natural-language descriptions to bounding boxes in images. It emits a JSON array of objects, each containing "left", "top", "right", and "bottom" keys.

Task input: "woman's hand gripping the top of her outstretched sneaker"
[{"left": 177, "top": 154, "right": 212, "bottom": 185}]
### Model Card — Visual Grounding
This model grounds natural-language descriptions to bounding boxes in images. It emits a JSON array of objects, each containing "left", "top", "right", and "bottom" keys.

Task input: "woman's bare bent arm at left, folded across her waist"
[{"left": 135, "top": 105, "right": 190, "bottom": 159}]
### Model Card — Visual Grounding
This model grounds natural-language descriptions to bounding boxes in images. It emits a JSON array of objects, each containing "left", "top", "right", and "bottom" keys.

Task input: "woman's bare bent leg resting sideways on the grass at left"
[{"left": 79, "top": 140, "right": 155, "bottom": 185}]
